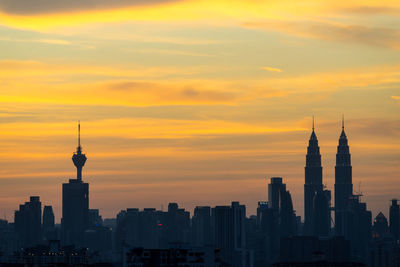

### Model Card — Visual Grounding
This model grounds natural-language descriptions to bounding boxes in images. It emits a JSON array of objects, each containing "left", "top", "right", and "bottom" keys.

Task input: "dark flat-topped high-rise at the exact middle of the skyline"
[{"left": 192, "top": 206, "right": 213, "bottom": 247}]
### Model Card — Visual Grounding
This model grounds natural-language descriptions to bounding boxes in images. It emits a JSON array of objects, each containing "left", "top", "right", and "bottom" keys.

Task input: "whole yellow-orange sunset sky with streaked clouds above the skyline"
[{"left": 0, "top": 0, "right": 400, "bottom": 222}]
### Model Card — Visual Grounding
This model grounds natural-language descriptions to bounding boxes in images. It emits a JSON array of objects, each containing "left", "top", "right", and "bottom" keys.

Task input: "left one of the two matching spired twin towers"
[{"left": 304, "top": 119, "right": 323, "bottom": 235}]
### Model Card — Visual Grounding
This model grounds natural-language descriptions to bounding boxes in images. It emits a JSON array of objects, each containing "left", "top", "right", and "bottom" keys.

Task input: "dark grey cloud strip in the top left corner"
[{"left": 0, "top": 0, "right": 174, "bottom": 15}]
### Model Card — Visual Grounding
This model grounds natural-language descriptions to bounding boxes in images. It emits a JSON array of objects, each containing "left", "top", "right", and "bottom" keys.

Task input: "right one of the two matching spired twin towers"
[{"left": 335, "top": 119, "right": 353, "bottom": 235}]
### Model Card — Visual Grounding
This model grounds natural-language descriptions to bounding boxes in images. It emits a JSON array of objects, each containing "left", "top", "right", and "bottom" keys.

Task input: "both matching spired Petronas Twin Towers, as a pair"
[{"left": 304, "top": 118, "right": 353, "bottom": 236}]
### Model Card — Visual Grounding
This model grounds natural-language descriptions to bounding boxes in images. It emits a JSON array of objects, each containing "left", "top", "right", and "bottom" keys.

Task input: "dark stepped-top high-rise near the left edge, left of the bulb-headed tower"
[{"left": 14, "top": 196, "right": 42, "bottom": 248}]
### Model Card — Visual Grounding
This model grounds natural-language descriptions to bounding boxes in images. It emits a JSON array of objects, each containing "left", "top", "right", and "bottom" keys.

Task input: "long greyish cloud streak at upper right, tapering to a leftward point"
[{"left": 243, "top": 20, "right": 400, "bottom": 49}]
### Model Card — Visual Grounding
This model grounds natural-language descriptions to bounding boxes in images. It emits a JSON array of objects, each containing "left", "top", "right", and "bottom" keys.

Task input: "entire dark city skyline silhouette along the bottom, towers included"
[{"left": 0, "top": 120, "right": 400, "bottom": 267}]
